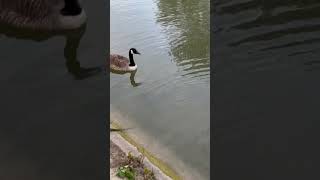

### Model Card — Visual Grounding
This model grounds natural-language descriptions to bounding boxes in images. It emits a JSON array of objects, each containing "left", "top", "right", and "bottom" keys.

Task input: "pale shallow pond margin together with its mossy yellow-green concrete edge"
[{"left": 110, "top": 106, "right": 206, "bottom": 180}]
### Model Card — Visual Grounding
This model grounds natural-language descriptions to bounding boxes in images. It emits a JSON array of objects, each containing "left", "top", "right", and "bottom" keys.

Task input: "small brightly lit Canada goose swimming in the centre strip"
[{"left": 110, "top": 48, "right": 140, "bottom": 72}]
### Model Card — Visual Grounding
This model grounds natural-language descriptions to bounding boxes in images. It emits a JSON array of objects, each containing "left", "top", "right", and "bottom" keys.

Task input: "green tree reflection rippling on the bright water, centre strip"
[{"left": 156, "top": 0, "right": 210, "bottom": 77}]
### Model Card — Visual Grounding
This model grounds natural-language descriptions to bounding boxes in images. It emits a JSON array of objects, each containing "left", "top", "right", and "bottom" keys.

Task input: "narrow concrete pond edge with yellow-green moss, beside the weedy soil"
[{"left": 110, "top": 122, "right": 182, "bottom": 180}]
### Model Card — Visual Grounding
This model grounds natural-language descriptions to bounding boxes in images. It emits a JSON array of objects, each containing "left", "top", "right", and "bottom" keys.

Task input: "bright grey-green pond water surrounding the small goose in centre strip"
[{"left": 110, "top": 0, "right": 210, "bottom": 179}]
